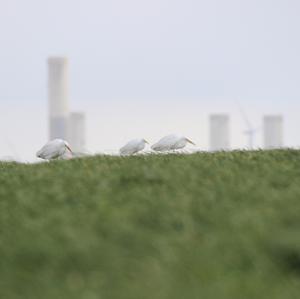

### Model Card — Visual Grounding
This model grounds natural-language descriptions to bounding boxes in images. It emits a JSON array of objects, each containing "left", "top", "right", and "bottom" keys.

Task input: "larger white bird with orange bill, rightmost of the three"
[{"left": 151, "top": 135, "right": 195, "bottom": 152}]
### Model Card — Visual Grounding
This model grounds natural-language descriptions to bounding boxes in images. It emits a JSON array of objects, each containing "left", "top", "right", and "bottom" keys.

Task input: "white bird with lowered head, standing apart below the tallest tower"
[{"left": 36, "top": 139, "right": 73, "bottom": 160}]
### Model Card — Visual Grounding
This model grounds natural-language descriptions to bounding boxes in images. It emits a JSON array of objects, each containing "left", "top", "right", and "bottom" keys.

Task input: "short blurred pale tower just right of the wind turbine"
[{"left": 264, "top": 115, "right": 283, "bottom": 149}]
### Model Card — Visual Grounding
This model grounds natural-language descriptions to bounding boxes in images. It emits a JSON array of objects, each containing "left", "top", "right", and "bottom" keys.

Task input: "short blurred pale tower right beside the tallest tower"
[{"left": 68, "top": 112, "right": 86, "bottom": 153}]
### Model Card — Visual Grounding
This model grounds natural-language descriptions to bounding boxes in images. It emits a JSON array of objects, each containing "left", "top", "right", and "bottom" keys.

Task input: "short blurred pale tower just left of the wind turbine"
[{"left": 210, "top": 114, "right": 230, "bottom": 151}]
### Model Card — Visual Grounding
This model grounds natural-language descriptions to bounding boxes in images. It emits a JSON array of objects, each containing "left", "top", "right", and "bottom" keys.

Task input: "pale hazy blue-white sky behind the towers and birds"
[{"left": 0, "top": 0, "right": 300, "bottom": 161}]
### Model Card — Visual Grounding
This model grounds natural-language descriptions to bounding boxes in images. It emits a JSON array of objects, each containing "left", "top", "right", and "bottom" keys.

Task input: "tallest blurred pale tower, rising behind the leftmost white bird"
[{"left": 48, "top": 57, "right": 69, "bottom": 140}]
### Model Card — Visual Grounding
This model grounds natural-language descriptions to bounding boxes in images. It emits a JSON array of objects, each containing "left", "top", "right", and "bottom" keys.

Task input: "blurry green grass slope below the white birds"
[{"left": 0, "top": 150, "right": 300, "bottom": 299}]
